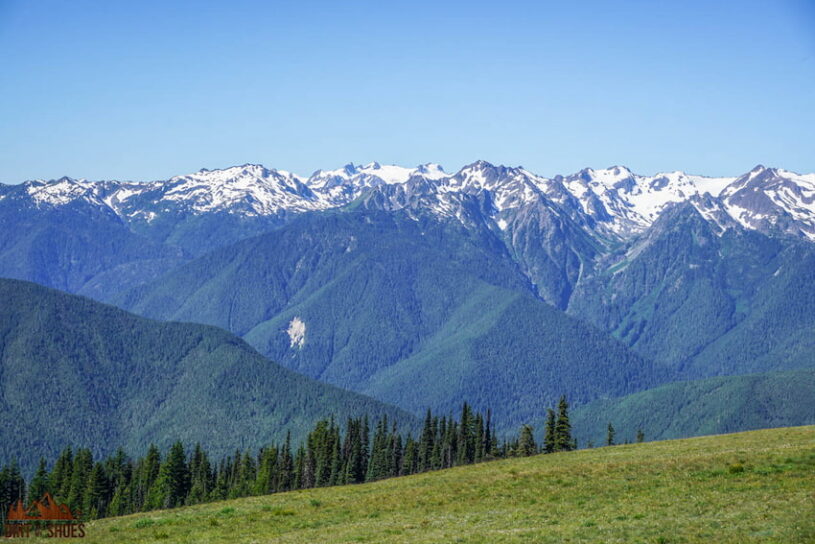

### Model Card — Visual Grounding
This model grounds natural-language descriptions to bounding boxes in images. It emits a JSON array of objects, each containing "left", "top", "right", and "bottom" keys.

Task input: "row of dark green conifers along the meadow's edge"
[{"left": 0, "top": 397, "right": 577, "bottom": 519}]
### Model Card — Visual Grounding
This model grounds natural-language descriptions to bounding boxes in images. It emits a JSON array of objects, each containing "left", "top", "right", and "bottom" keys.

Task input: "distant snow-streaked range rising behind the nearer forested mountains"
[{"left": 0, "top": 161, "right": 815, "bottom": 309}]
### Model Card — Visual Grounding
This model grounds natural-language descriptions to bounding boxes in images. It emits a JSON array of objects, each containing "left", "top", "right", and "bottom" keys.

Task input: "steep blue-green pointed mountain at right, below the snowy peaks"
[{"left": 569, "top": 203, "right": 815, "bottom": 378}]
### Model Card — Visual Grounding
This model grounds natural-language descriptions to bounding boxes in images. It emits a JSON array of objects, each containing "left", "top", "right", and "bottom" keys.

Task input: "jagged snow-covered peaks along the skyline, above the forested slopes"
[{"left": 6, "top": 161, "right": 815, "bottom": 240}]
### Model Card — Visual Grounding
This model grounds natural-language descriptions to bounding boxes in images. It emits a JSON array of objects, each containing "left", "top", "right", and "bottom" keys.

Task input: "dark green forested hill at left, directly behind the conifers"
[{"left": 0, "top": 280, "right": 414, "bottom": 472}]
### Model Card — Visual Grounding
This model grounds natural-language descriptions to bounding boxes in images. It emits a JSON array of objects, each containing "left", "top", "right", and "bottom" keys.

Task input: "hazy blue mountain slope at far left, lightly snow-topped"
[{"left": 0, "top": 183, "right": 186, "bottom": 298}]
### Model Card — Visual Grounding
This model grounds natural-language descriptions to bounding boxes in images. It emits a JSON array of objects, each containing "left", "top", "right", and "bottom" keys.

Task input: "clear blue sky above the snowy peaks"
[{"left": 0, "top": 0, "right": 815, "bottom": 183}]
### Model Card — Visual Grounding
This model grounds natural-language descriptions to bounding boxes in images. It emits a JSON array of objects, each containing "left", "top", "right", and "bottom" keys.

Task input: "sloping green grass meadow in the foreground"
[{"left": 36, "top": 426, "right": 815, "bottom": 544}]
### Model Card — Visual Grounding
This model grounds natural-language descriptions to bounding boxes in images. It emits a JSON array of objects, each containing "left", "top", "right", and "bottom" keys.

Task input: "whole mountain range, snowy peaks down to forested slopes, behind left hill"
[{"left": 0, "top": 161, "right": 815, "bottom": 460}]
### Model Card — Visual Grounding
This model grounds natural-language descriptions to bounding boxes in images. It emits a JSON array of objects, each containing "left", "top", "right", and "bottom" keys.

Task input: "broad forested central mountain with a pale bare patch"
[{"left": 120, "top": 208, "right": 661, "bottom": 428}]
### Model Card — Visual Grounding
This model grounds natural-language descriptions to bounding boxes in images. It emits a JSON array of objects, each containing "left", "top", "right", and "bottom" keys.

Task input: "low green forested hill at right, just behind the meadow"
[{"left": 572, "top": 370, "right": 815, "bottom": 445}]
